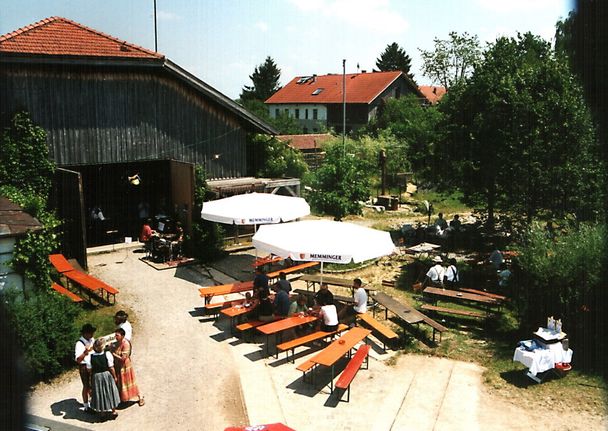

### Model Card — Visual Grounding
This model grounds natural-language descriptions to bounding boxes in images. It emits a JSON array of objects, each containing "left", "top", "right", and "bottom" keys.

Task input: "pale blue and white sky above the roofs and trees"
[{"left": 0, "top": 0, "right": 573, "bottom": 99}]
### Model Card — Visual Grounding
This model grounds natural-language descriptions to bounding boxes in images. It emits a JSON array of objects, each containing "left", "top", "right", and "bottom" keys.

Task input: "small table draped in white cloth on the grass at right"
[{"left": 513, "top": 328, "right": 573, "bottom": 383}]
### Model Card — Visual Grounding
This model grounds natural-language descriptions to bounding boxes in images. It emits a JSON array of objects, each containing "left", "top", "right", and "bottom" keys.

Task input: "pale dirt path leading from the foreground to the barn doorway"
[{"left": 29, "top": 251, "right": 246, "bottom": 430}]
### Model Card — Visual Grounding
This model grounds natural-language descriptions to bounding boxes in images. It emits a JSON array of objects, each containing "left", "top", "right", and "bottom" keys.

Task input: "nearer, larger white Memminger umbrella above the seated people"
[{"left": 253, "top": 220, "right": 395, "bottom": 276}]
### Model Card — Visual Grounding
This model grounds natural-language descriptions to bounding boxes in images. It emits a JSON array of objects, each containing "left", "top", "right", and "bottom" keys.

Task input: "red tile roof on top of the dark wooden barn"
[{"left": 0, "top": 17, "right": 164, "bottom": 59}]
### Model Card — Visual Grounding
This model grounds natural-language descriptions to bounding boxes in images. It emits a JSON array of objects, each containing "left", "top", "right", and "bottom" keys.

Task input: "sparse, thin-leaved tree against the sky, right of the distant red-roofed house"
[{"left": 419, "top": 31, "right": 481, "bottom": 90}]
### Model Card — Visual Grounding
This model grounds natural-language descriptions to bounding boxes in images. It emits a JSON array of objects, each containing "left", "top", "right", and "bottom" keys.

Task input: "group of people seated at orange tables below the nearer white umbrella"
[{"left": 246, "top": 267, "right": 367, "bottom": 332}]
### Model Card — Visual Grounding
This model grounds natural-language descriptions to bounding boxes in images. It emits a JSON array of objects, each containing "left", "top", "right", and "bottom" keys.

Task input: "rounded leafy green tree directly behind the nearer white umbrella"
[{"left": 309, "top": 140, "right": 375, "bottom": 220}]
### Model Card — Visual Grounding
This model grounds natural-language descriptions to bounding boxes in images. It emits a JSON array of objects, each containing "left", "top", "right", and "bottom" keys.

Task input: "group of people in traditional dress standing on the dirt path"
[{"left": 74, "top": 310, "right": 145, "bottom": 418}]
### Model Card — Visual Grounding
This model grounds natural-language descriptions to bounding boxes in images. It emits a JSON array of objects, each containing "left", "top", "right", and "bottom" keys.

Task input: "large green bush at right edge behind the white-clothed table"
[{"left": 514, "top": 224, "right": 608, "bottom": 371}]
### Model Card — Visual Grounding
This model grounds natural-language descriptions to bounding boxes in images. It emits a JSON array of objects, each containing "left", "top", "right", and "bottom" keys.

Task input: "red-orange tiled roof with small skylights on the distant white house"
[{"left": 265, "top": 71, "right": 402, "bottom": 104}]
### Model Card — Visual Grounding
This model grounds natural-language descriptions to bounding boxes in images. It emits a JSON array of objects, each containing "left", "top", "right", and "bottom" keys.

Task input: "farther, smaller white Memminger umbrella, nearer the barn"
[{"left": 201, "top": 193, "right": 310, "bottom": 225}]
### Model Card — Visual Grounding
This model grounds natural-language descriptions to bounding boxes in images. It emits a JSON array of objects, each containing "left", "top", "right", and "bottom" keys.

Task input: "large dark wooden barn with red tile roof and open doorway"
[{"left": 0, "top": 17, "right": 274, "bottom": 264}]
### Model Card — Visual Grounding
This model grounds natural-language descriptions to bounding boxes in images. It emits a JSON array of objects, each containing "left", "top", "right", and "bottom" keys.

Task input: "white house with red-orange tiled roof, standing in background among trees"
[{"left": 265, "top": 71, "right": 424, "bottom": 133}]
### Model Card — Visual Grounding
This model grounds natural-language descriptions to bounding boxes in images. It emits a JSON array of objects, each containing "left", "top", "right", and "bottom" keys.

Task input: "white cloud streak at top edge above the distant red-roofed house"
[{"left": 291, "top": 0, "right": 409, "bottom": 34}]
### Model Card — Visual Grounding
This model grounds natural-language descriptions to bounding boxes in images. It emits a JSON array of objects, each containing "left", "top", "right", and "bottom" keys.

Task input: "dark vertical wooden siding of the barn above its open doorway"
[{"left": 0, "top": 64, "right": 247, "bottom": 178}]
